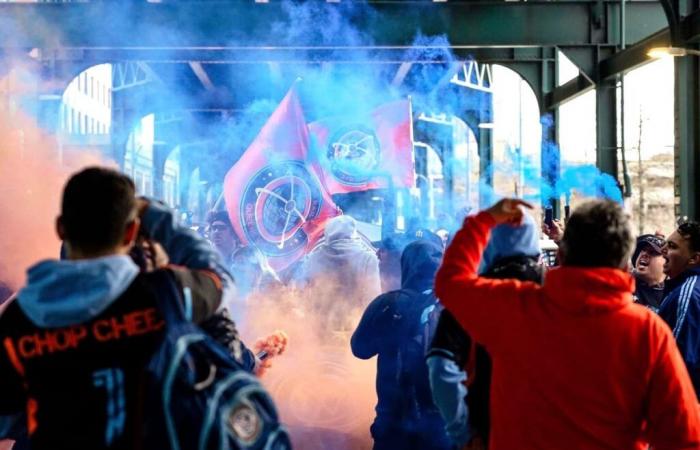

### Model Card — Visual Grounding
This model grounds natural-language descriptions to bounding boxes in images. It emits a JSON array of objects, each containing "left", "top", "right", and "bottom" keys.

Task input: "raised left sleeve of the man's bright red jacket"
[{"left": 435, "top": 211, "right": 538, "bottom": 347}]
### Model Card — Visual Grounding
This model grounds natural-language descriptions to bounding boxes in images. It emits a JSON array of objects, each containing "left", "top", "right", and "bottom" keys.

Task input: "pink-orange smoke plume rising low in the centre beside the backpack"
[{"left": 241, "top": 286, "right": 377, "bottom": 450}]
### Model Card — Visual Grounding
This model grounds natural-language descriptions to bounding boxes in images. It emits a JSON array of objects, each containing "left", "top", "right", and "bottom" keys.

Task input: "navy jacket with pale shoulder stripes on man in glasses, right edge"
[{"left": 659, "top": 268, "right": 700, "bottom": 399}]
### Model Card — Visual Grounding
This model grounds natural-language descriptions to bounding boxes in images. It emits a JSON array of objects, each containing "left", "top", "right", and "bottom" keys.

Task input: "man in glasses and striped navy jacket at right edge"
[{"left": 659, "top": 222, "right": 700, "bottom": 398}]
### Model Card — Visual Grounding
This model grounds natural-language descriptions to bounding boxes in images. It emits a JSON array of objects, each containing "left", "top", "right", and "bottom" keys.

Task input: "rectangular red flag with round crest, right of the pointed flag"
[{"left": 309, "top": 100, "right": 415, "bottom": 194}]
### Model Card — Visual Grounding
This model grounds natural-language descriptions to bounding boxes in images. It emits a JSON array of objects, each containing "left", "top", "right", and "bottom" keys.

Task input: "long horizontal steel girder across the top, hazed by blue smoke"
[{"left": 0, "top": 0, "right": 665, "bottom": 52}]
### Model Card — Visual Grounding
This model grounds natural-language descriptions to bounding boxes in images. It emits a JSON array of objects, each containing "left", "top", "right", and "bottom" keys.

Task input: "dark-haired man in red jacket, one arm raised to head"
[{"left": 435, "top": 199, "right": 700, "bottom": 450}]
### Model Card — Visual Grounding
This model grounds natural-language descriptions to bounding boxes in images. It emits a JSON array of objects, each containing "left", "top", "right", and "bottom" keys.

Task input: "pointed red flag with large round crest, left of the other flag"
[{"left": 224, "top": 86, "right": 339, "bottom": 270}]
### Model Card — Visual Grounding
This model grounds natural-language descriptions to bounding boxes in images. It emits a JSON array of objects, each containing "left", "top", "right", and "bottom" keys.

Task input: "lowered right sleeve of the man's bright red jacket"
[{"left": 647, "top": 318, "right": 700, "bottom": 450}]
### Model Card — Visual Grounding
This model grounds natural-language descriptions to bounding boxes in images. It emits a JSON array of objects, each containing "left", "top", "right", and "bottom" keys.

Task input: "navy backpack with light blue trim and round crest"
[{"left": 142, "top": 271, "right": 291, "bottom": 450}]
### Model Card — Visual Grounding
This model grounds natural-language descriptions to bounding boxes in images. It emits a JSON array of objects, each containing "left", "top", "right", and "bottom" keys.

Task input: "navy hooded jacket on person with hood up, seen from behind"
[{"left": 350, "top": 241, "right": 444, "bottom": 435}]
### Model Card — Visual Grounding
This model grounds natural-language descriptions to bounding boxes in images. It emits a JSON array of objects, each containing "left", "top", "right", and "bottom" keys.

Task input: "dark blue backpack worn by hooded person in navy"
[{"left": 396, "top": 289, "right": 443, "bottom": 419}]
